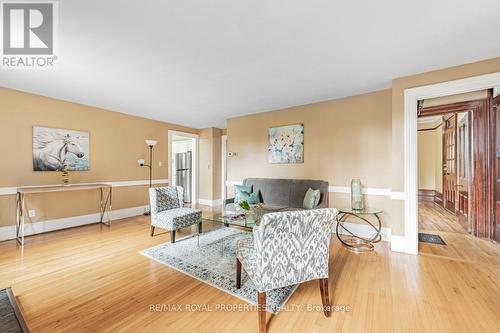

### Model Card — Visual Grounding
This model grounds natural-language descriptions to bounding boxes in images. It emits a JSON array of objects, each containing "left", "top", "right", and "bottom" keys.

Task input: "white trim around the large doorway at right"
[{"left": 400, "top": 72, "right": 500, "bottom": 254}]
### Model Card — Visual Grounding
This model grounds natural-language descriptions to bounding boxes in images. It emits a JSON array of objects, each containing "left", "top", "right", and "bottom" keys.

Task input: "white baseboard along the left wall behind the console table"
[{"left": 0, "top": 202, "right": 149, "bottom": 241}]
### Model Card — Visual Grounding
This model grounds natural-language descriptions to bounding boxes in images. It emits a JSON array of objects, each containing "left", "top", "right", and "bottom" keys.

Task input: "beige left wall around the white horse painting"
[{"left": 0, "top": 88, "right": 198, "bottom": 226}]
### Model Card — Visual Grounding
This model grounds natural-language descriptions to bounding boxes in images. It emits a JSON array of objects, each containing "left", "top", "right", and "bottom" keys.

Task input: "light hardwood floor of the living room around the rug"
[{"left": 0, "top": 217, "right": 500, "bottom": 333}]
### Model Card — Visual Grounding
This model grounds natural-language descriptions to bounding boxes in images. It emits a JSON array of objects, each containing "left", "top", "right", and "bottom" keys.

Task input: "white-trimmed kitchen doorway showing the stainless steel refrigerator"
[{"left": 168, "top": 131, "right": 199, "bottom": 205}]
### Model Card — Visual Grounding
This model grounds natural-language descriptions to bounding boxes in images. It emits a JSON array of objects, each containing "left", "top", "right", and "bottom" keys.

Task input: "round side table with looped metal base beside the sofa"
[{"left": 336, "top": 208, "right": 382, "bottom": 253}]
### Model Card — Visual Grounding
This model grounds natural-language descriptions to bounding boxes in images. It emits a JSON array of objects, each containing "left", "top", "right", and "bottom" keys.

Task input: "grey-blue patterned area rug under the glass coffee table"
[{"left": 139, "top": 228, "right": 297, "bottom": 314}]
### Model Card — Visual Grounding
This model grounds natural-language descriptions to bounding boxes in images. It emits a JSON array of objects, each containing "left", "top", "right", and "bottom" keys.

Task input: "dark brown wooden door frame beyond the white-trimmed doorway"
[{"left": 417, "top": 96, "right": 495, "bottom": 239}]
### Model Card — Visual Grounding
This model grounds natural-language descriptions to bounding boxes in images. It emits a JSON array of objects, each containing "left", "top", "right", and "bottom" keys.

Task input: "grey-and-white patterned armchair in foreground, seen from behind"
[{"left": 236, "top": 208, "right": 338, "bottom": 332}]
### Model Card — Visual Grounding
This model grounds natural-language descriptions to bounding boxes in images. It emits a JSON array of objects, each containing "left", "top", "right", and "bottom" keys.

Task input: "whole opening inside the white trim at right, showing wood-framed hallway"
[{"left": 417, "top": 89, "right": 496, "bottom": 258}]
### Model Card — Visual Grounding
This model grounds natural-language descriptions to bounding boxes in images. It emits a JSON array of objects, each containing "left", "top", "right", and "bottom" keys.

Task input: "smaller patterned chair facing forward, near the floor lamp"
[{"left": 149, "top": 186, "right": 202, "bottom": 243}]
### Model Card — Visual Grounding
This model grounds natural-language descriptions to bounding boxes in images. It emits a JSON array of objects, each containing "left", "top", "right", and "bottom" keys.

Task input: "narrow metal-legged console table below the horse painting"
[{"left": 16, "top": 184, "right": 113, "bottom": 246}]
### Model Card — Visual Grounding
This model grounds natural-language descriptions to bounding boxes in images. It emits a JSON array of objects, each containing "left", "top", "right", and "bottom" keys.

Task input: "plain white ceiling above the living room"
[{"left": 0, "top": 0, "right": 500, "bottom": 128}]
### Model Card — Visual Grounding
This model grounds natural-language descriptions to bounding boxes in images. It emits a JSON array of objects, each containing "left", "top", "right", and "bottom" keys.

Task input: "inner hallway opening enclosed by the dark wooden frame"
[{"left": 418, "top": 112, "right": 471, "bottom": 238}]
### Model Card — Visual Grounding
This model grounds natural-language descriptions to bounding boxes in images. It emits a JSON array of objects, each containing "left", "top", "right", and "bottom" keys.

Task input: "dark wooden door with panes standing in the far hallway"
[{"left": 443, "top": 113, "right": 457, "bottom": 213}]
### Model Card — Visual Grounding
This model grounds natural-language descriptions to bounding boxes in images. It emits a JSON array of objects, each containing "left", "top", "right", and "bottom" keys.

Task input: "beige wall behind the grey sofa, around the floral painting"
[{"left": 227, "top": 90, "right": 392, "bottom": 226}]
